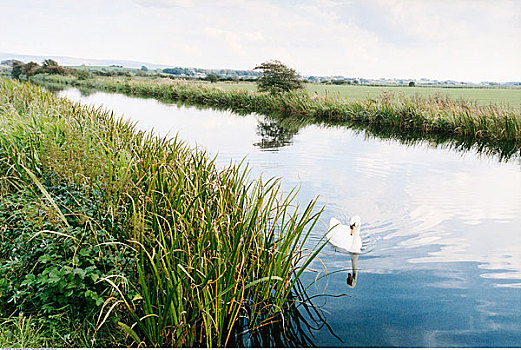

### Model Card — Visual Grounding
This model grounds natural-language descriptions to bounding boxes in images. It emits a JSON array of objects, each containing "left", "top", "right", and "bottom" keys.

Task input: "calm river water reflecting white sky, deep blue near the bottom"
[{"left": 59, "top": 89, "right": 521, "bottom": 347}]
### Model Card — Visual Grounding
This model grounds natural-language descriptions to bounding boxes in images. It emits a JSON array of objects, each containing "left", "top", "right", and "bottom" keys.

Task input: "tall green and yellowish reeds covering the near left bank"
[{"left": 0, "top": 80, "right": 321, "bottom": 346}]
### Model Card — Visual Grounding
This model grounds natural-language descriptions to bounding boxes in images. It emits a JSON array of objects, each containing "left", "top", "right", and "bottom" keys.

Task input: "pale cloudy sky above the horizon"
[{"left": 0, "top": 0, "right": 521, "bottom": 82}]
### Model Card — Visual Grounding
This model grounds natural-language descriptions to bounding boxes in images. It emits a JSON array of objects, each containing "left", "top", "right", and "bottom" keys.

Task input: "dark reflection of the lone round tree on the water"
[{"left": 253, "top": 119, "right": 298, "bottom": 150}]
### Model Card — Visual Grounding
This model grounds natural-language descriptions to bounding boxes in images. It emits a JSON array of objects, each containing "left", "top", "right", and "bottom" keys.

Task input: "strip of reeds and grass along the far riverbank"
[{"left": 33, "top": 74, "right": 521, "bottom": 142}]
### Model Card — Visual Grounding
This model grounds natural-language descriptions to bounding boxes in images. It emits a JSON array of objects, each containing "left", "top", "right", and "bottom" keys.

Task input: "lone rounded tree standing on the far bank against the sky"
[{"left": 254, "top": 61, "right": 303, "bottom": 94}]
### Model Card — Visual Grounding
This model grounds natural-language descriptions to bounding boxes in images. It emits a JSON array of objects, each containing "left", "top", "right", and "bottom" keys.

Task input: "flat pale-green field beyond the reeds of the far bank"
[{"left": 213, "top": 82, "right": 521, "bottom": 109}]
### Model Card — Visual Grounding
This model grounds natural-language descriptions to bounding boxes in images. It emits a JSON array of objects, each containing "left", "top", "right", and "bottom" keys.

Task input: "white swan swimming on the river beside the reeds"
[{"left": 326, "top": 216, "right": 362, "bottom": 253}]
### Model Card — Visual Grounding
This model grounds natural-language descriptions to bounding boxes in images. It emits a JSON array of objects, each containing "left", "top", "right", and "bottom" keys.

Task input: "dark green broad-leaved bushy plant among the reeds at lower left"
[{"left": 0, "top": 179, "right": 133, "bottom": 317}]
